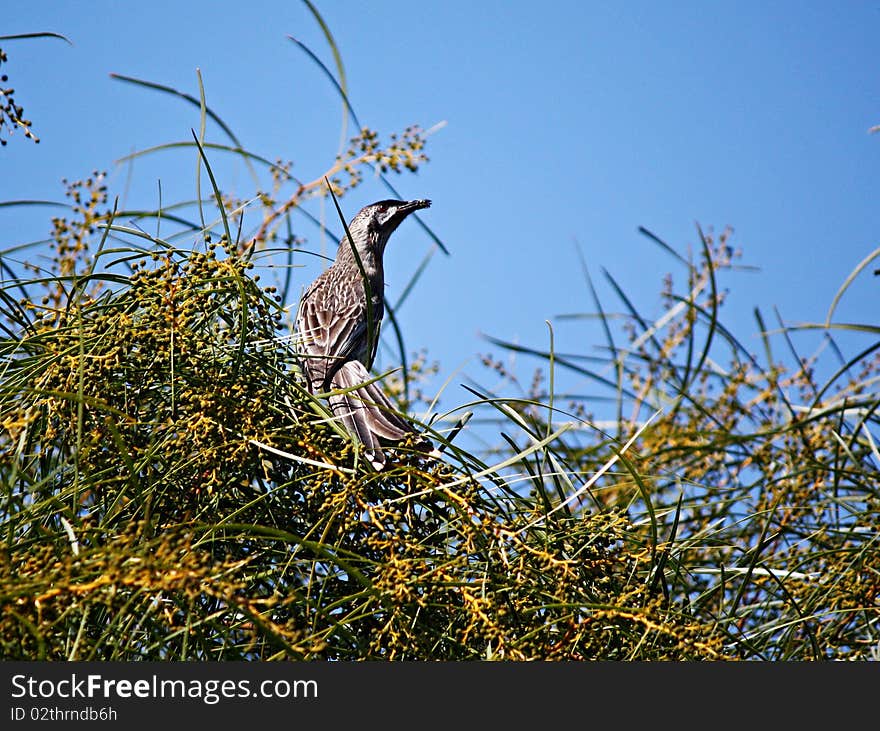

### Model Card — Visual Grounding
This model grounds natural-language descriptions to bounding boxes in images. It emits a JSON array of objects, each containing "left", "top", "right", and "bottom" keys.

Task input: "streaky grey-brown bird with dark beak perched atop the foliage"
[{"left": 296, "top": 199, "right": 436, "bottom": 471}]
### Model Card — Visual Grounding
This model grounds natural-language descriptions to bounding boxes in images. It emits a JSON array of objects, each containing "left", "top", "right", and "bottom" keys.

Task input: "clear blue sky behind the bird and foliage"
[{"left": 0, "top": 0, "right": 880, "bottom": 426}]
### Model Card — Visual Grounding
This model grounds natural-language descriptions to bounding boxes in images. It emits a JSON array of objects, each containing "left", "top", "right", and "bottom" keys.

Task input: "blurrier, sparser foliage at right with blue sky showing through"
[{"left": 489, "top": 229, "right": 880, "bottom": 660}]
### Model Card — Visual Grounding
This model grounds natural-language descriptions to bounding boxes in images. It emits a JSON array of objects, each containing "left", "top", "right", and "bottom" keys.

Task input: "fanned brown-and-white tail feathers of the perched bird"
[{"left": 329, "top": 360, "right": 433, "bottom": 470}]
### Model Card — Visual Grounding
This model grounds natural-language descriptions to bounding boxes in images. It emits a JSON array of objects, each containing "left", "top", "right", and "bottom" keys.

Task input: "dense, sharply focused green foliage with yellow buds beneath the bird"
[{"left": 0, "top": 176, "right": 720, "bottom": 659}]
